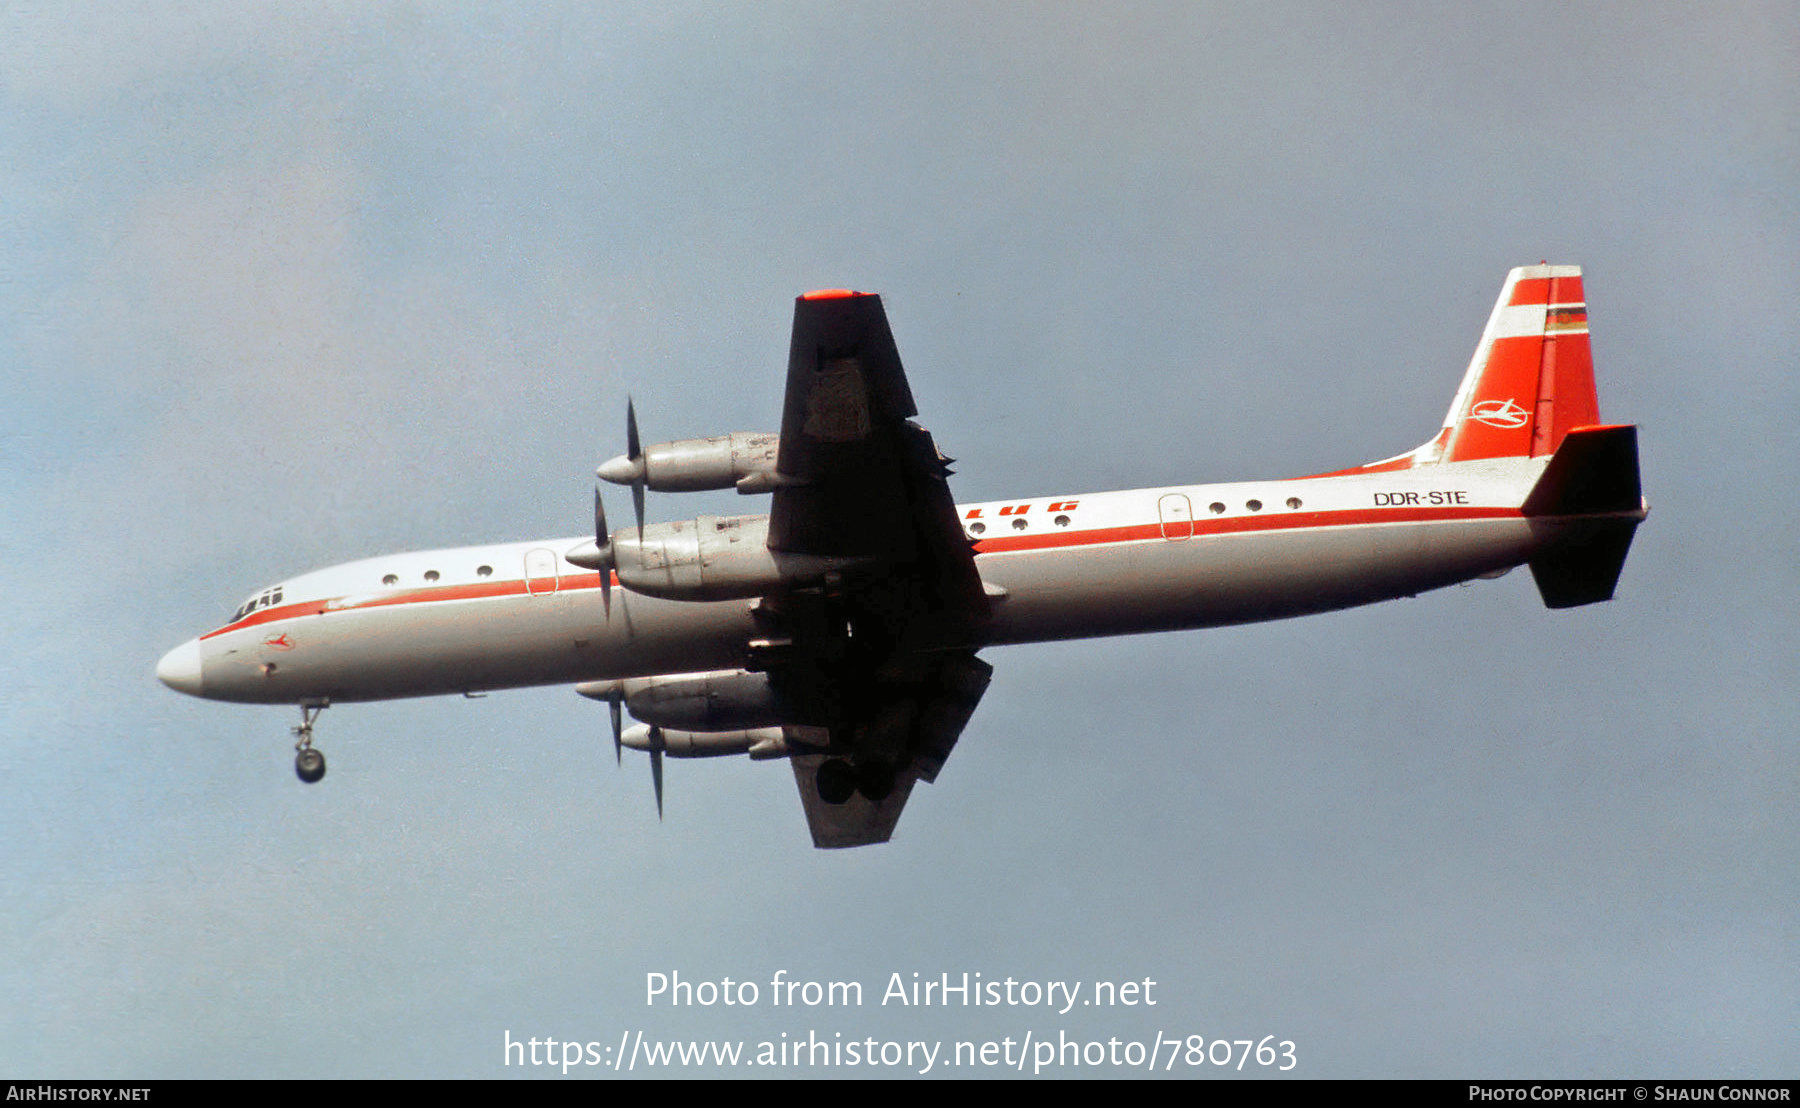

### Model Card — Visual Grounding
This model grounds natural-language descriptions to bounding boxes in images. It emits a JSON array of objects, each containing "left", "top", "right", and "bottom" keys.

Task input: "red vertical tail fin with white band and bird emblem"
[{"left": 1418, "top": 266, "right": 1600, "bottom": 462}]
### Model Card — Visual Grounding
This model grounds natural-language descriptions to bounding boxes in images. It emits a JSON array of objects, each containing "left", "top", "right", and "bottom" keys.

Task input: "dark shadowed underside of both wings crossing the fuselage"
[{"left": 760, "top": 291, "right": 992, "bottom": 847}]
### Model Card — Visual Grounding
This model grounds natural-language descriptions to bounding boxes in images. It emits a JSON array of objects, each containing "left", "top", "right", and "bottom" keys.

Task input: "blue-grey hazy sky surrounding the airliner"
[{"left": 0, "top": 0, "right": 1800, "bottom": 1077}]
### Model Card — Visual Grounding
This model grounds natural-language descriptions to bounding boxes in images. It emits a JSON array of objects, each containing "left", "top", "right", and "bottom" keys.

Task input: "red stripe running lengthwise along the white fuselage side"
[{"left": 202, "top": 507, "right": 1519, "bottom": 639}]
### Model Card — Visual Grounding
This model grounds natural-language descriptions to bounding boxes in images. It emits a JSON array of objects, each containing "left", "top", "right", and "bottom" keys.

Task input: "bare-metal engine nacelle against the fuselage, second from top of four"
[{"left": 612, "top": 516, "right": 848, "bottom": 601}]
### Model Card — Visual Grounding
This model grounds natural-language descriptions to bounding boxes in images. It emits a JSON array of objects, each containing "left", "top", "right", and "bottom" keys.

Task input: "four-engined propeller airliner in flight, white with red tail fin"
[{"left": 157, "top": 264, "right": 1649, "bottom": 847}]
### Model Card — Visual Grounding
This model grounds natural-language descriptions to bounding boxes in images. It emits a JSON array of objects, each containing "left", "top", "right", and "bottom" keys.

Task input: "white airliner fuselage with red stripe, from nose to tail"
[{"left": 158, "top": 457, "right": 1561, "bottom": 703}]
